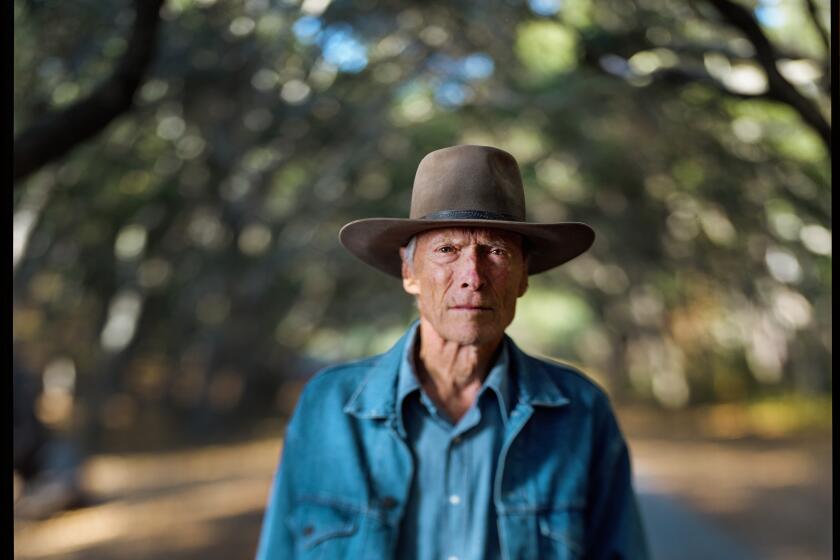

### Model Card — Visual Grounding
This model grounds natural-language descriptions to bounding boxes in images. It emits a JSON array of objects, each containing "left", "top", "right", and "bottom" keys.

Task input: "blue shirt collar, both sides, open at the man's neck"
[{"left": 396, "top": 322, "right": 511, "bottom": 429}]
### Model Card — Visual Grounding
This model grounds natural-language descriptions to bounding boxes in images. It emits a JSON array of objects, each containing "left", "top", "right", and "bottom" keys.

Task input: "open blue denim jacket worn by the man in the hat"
[{"left": 257, "top": 326, "right": 648, "bottom": 560}]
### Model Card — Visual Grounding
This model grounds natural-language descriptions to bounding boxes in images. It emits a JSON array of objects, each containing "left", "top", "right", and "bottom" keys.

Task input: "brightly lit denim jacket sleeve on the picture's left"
[{"left": 256, "top": 398, "right": 303, "bottom": 560}]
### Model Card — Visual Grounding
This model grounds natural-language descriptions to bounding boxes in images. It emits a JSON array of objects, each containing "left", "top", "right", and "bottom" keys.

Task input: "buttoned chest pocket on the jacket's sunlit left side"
[{"left": 291, "top": 498, "right": 360, "bottom": 558}]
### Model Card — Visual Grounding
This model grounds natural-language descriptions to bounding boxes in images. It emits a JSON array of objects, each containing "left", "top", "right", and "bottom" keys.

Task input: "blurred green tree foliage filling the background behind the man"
[{"left": 14, "top": 0, "right": 831, "bottom": 445}]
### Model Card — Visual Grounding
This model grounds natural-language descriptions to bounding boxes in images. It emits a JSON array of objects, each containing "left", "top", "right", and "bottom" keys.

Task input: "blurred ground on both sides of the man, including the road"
[{"left": 14, "top": 406, "right": 832, "bottom": 560}]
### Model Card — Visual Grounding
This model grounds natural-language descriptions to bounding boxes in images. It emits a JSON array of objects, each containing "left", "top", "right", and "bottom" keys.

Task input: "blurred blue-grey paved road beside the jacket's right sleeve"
[{"left": 636, "top": 476, "right": 757, "bottom": 560}]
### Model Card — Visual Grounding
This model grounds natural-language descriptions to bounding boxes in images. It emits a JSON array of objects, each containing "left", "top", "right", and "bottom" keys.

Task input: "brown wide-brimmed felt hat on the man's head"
[{"left": 338, "top": 145, "right": 595, "bottom": 278}]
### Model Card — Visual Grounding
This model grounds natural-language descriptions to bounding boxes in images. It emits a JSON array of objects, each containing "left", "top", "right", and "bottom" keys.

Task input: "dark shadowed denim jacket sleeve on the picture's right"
[{"left": 586, "top": 396, "right": 650, "bottom": 560}]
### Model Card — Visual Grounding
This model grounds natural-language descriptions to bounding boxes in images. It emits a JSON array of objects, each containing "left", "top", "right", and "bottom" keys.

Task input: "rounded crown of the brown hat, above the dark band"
[{"left": 410, "top": 145, "right": 525, "bottom": 221}]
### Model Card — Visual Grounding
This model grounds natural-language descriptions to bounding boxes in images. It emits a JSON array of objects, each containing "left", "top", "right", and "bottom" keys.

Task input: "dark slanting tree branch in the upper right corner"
[{"left": 708, "top": 0, "right": 831, "bottom": 153}]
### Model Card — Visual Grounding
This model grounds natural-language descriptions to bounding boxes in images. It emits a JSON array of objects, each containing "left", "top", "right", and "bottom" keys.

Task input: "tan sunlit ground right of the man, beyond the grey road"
[{"left": 618, "top": 407, "right": 832, "bottom": 560}]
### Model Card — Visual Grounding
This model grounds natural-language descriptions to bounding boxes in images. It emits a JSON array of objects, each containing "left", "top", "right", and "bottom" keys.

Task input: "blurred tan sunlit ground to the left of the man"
[{"left": 15, "top": 439, "right": 281, "bottom": 559}]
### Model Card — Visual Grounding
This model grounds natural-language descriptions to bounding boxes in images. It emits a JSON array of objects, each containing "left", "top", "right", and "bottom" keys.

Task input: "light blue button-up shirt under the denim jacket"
[{"left": 397, "top": 326, "right": 510, "bottom": 560}]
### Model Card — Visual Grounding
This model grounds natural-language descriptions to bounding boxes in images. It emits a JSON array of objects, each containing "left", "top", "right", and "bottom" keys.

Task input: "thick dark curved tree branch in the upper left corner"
[{"left": 13, "top": 0, "right": 164, "bottom": 186}]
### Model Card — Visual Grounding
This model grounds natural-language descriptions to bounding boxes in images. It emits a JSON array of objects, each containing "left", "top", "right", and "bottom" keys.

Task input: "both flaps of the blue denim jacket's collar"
[{"left": 344, "top": 321, "right": 569, "bottom": 420}]
